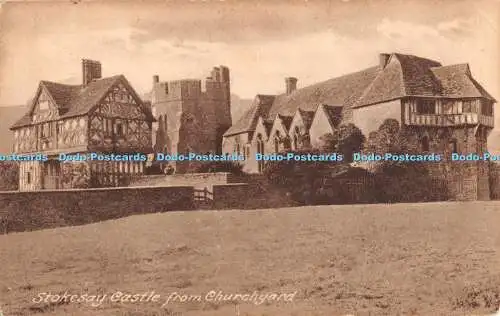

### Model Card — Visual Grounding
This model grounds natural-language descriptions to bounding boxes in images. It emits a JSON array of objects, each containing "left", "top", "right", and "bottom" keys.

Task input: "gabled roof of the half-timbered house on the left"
[{"left": 11, "top": 75, "right": 154, "bottom": 129}]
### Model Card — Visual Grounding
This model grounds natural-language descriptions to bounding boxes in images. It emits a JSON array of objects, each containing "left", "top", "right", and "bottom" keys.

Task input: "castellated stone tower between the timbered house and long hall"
[{"left": 151, "top": 66, "right": 232, "bottom": 173}]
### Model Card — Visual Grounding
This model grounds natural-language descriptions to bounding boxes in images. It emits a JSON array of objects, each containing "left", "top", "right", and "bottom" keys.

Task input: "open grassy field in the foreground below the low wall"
[{"left": 0, "top": 202, "right": 500, "bottom": 316}]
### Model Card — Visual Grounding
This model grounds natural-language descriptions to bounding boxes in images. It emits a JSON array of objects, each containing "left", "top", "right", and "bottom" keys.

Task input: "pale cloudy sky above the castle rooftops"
[{"left": 0, "top": 0, "right": 500, "bottom": 110}]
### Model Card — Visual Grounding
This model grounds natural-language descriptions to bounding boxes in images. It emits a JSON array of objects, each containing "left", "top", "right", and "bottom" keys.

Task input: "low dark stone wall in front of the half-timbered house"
[{"left": 0, "top": 186, "right": 194, "bottom": 233}]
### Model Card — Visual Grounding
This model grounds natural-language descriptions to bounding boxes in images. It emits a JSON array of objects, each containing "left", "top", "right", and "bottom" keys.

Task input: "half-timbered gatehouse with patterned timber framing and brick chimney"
[{"left": 11, "top": 59, "right": 154, "bottom": 191}]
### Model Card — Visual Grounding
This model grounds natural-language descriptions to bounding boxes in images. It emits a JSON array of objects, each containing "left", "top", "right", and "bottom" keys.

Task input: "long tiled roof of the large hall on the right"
[{"left": 225, "top": 53, "right": 495, "bottom": 136}]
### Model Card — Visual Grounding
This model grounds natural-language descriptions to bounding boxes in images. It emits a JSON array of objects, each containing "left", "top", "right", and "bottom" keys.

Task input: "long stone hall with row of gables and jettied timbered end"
[{"left": 223, "top": 53, "right": 496, "bottom": 199}]
